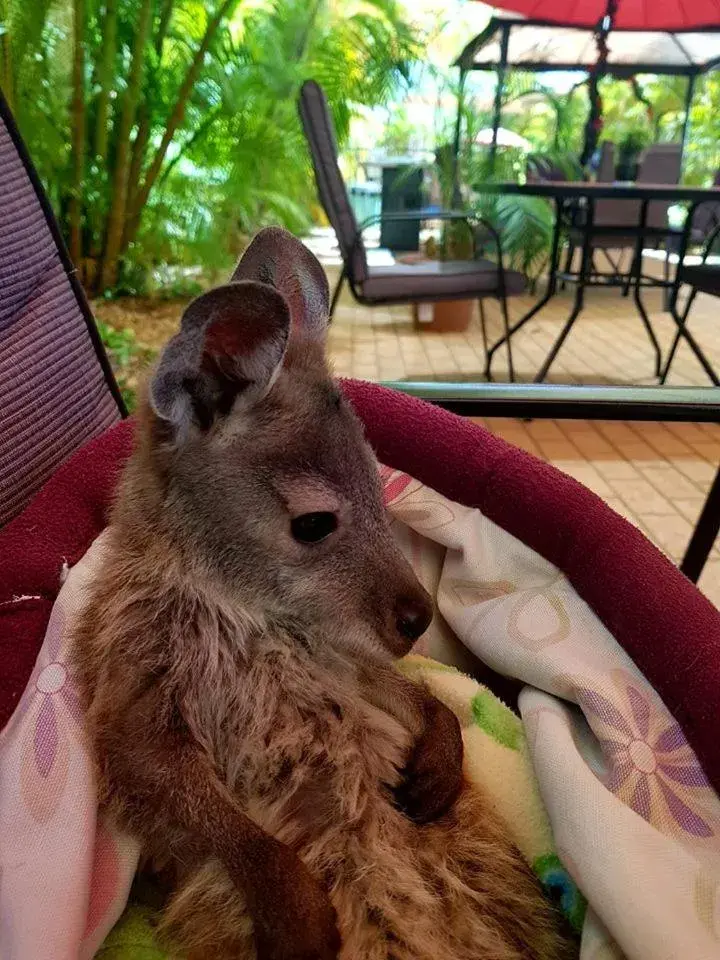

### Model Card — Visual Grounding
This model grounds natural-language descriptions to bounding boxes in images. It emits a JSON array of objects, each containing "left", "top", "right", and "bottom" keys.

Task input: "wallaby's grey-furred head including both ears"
[{"left": 144, "top": 228, "right": 429, "bottom": 649}]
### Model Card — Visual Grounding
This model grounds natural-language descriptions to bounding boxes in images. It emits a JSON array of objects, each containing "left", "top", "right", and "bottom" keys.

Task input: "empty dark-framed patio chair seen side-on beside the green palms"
[{"left": 299, "top": 80, "right": 525, "bottom": 381}]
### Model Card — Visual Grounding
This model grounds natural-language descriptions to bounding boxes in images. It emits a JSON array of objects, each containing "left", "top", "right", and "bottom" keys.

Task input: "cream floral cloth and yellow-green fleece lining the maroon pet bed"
[{"left": 0, "top": 469, "right": 720, "bottom": 960}]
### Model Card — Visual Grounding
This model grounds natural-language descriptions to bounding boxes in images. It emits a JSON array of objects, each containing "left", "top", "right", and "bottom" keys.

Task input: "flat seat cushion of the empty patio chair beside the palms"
[{"left": 361, "top": 260, "right": 525, "bottom": 302}]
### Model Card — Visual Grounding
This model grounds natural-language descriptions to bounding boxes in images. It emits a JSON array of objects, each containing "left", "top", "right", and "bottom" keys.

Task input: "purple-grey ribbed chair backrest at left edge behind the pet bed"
[{"left": 0, "top": 95, "right": 124, "bottom": 527}]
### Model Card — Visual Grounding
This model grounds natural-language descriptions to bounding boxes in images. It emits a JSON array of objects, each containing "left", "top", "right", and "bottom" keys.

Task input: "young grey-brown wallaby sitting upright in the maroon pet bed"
[{"left": 74, "top": 228, "right": 576, "bottom": 960}]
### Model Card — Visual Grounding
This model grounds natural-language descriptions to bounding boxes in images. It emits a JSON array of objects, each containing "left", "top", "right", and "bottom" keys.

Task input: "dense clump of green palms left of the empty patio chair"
[{"left": 0, "top": 0, "right": 420, "bottom": 293}]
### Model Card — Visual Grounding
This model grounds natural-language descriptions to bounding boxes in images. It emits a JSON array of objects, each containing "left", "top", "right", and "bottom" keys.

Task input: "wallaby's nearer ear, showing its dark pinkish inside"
[{"left": 150, "top": 281, "right": 290, "bottom": 434}]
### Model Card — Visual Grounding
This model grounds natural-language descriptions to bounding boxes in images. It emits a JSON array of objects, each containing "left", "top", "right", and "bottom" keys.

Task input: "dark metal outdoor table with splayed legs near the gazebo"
[{"left": 479, "top": 181, "right": 720, "bottom": 386}]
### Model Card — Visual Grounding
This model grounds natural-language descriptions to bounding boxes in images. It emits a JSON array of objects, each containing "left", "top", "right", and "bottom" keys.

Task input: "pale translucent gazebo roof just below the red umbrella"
[{"left": 456, "top": 17, "right": 720, "bottom": 78}]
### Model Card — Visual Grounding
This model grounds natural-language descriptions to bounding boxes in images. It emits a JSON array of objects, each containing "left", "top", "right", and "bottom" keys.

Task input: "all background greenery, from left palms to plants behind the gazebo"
[{"left": 8, "top": 0, "right": 720, "bottom": 295}]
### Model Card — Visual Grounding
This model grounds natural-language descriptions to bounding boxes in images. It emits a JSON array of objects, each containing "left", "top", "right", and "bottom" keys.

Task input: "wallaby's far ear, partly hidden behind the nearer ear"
[{"left": 232, "top": 227, "right": 330, "bottom": 340}]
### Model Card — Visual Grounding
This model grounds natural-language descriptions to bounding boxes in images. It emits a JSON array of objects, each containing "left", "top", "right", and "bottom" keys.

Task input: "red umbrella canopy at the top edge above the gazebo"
[{"left": 480, "top": 0, "right": 720, "bottom": 30}]
